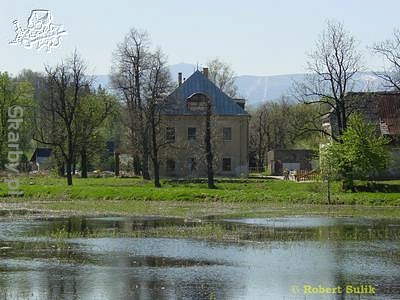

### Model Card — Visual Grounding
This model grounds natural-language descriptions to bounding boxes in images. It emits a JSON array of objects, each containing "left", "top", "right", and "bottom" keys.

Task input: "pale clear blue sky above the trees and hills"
[{"left": 0, "top": 0, "right": 400, "bottom": 75}]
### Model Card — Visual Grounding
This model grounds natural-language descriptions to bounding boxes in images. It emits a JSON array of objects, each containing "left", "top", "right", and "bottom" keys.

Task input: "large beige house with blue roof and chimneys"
[{"left": 160, "top": 68, "right": 249, "bottom": 177}]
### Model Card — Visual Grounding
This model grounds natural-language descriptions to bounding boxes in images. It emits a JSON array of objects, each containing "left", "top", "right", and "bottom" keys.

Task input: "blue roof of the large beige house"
[{"left": 162, "top": 70, "right": 249, "bottom": 116}]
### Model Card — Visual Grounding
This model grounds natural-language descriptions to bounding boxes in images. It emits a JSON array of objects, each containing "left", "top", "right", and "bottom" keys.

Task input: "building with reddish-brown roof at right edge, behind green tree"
[{"left": 322, "top": 92, "right": 400, "bottom": 178}]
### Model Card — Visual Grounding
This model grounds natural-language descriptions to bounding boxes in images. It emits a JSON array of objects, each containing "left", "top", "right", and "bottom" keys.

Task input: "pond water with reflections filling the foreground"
[{"left": 0, "top": 217, "right": 400, "bottom": 300}]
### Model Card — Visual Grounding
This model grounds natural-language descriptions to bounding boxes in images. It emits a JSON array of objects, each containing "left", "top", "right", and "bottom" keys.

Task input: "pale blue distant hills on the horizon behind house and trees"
[{"left": 95, "top": 63, "right": 383, "bottom": 105}]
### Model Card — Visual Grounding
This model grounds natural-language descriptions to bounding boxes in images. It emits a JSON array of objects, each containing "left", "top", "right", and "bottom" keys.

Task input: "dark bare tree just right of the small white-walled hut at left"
[{"left": 34, "top": 51, "right": 91, "bottom": 185}]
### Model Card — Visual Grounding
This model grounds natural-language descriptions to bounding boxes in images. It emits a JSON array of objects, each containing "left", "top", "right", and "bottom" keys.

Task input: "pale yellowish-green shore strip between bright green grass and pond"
[{"left": 0, "top": 200, "right": 400, "bottom": 219}]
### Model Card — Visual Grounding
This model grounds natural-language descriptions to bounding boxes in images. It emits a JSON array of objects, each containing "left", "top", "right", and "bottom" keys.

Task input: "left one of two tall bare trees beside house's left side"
[{"left": 112, "top": 28, "right": 150, "bottom": 179}]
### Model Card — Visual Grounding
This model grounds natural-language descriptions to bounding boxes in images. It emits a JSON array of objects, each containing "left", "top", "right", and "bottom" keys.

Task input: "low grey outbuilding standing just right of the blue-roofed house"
[{"left": 267, "top": 149, "right": 316, "bottom": 176}]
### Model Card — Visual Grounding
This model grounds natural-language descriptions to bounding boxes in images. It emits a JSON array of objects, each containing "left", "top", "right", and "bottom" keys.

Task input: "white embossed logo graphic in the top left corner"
[{"left": 9, "top": 9, "right": 67, "bottom": 53}]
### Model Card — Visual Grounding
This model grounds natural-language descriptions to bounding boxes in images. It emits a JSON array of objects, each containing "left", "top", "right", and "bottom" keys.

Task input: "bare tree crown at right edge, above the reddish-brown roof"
[{"left": 373, "top": 29, "right": 400, "bottom": 91}]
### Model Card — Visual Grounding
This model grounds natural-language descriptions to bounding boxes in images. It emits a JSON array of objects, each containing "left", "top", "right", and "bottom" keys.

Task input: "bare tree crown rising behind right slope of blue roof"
[{"left": 206, "top": 58, "right": 238, "bottom": 98}]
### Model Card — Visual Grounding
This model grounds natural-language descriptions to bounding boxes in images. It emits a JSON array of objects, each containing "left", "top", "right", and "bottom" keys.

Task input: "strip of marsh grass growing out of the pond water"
[{"left": 32, "top": 222, "right": 399, "bottom": 243}]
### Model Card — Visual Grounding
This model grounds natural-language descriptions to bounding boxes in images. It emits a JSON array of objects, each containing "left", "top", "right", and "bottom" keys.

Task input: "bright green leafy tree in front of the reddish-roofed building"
[{"left": 325, "top": 114, "right": 389, "bottom": 190}]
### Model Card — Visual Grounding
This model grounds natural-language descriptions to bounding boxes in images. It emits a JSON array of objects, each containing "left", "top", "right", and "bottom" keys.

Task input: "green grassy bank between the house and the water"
[{"left": 0, "top": 173, "right": 400, "bottom": 218}]
